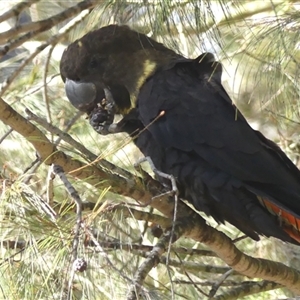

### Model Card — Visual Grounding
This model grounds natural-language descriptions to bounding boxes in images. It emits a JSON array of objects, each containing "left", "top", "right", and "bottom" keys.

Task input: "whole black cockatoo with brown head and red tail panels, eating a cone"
[{"left": 60, "top": 25, "right": 300, "bottom": 243}]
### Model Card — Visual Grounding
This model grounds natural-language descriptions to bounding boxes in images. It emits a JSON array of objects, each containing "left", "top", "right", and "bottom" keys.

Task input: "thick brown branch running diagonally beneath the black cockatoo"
[{"left": 0, "top": 98, "right": 300, "bottom": 295}]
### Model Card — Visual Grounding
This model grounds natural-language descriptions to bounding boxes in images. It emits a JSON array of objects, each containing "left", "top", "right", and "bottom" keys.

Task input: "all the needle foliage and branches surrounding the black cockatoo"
[{"left": 0, "top": 0, "right": 300, "bottom": 299}]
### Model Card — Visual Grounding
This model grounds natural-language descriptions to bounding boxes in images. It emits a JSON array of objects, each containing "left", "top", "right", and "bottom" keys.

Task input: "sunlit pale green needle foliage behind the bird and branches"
[{"left": 0, "top": 0, "right": 300, "bottom": 300}]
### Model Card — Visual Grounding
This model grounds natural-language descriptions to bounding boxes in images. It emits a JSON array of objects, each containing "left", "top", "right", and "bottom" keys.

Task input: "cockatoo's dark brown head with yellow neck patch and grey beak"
[{"left": 60, "top": 25, "right": 180, "bottom": 113}]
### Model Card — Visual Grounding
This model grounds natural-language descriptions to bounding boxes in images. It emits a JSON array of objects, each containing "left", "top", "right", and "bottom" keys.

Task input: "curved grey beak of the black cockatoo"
[{"left": 65, "top": 78, "right": 97, "bottom": 111}]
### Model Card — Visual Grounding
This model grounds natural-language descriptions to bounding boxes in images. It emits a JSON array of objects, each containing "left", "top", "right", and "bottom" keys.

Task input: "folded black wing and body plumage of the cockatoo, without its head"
[{"left": 138, "top": 54, "right": 300, "bottom": 240}]
